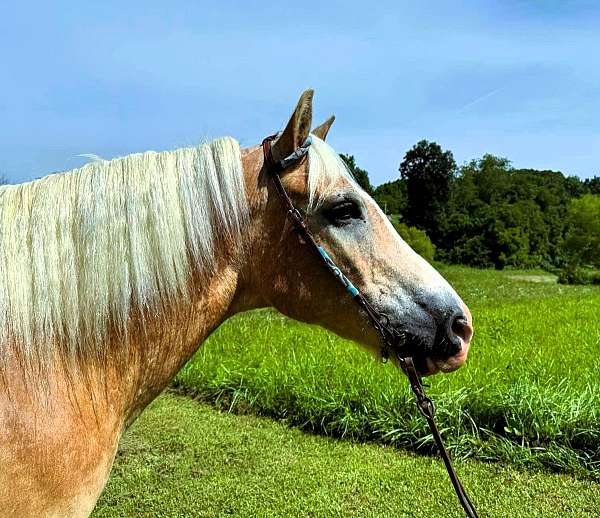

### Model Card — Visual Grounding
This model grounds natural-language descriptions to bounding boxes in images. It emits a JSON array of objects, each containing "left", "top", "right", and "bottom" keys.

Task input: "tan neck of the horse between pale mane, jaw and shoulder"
[{"left": 59, "top": 147, "right": 266, "bottom": 422}]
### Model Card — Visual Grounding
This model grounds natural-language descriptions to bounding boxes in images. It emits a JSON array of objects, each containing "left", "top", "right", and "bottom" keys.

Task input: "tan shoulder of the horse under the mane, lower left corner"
[{"left": 0, "top": 358, "right": 123, "bottom": 517}]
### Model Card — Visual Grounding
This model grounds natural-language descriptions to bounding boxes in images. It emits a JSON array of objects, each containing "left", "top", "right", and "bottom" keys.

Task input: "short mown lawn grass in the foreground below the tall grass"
[{"left": 93, "top": 394, "right": 600, "bottom": 518}]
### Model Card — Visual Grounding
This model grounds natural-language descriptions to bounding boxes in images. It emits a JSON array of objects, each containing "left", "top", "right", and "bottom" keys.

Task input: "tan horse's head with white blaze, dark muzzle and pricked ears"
[{"left": 244, "top": 90, "right": 473, "bottom": 375}]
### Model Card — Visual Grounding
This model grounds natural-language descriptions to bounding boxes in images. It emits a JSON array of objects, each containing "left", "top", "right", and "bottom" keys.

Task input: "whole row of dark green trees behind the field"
[{"left": 342, "top": 140, "right": 600, "bottom": 271}]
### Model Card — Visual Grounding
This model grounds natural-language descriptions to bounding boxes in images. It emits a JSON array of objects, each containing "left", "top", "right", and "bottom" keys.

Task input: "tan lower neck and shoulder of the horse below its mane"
[{"left": 0, "top": 256, "right": 248, "bottom": 516}]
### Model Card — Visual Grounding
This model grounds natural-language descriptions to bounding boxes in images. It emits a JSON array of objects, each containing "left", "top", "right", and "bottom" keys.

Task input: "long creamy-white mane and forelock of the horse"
[{"left": 0, "top": 137, "right": 350, "bottom": 366}]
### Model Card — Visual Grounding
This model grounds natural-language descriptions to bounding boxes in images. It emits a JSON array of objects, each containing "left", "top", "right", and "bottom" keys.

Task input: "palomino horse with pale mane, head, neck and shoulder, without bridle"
[{"left": 0, "top": 91, "right": 472, "bottom": 517}]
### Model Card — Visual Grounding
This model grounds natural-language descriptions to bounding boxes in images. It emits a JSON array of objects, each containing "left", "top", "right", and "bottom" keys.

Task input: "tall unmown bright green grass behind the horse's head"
[{"left": 176, "top": 267, "right": 600, "bottom": 478}]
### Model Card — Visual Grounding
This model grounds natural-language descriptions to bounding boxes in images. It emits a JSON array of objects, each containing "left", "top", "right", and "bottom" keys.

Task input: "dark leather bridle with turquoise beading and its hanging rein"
[{"left": 262, "top": 135, "right": 478, "bottom": 518}]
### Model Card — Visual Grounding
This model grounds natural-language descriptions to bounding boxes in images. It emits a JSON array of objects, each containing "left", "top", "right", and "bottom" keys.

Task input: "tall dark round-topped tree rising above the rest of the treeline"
[{"left": 400, "top": 140, "right": 456, "bottom": 244}]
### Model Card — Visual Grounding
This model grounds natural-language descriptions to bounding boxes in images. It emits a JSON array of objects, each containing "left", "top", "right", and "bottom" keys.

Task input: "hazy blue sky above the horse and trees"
[{"left": 0, "top": 0, "right": 600, "bottom": 184}]
